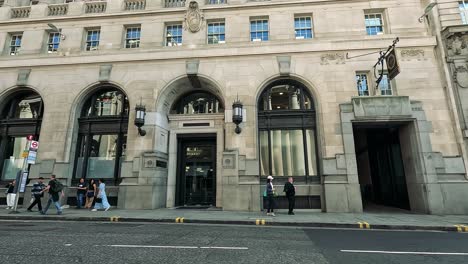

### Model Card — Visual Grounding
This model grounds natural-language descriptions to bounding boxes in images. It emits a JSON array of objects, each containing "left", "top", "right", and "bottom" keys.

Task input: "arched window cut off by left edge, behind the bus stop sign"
[{"left": 0, "top": 89, "right": 44, "bottom": 180}]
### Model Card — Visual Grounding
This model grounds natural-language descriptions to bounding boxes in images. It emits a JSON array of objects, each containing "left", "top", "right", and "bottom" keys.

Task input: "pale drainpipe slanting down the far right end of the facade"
[{"left": 429, "top": 0, "right": 468, "bottom": 177}]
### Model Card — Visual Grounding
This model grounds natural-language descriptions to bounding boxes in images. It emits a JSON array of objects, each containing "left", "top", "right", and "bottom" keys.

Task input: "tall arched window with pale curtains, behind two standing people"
[{"left": 258, "top": 79, "right": 319, "bottom": 182}]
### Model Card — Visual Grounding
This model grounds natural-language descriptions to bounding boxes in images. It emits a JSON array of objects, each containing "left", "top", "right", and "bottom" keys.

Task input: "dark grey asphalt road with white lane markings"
[{"left": 0, "top": 221, "right": 468, "bottom": 264}]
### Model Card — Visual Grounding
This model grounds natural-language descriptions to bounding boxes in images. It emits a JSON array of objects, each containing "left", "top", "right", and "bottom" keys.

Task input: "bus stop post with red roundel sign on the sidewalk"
[{"left": 10, "top": 135, "right": 39, "bottom": 213}]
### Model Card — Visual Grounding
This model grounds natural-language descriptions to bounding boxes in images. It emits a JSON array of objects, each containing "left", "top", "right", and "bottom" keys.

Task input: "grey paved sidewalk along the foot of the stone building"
[{"left": 0, "top": 207, "right": 468, "bottom": 232}]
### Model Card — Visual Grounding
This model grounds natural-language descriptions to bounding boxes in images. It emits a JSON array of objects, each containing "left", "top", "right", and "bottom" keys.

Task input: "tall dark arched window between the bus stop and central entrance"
[{"left": 74, "top": 87, "right": 129, "bottom": 180}]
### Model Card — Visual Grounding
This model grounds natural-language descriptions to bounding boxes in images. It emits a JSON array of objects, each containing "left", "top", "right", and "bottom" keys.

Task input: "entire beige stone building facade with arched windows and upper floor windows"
[{"left": 0, "top": 0, "right": 468, "bottom": 214}]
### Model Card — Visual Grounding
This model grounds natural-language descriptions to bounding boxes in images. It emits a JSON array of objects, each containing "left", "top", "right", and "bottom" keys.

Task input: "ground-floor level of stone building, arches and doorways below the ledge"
[{"left": 0, "top": 55, "right": 468, "bottom": 214}]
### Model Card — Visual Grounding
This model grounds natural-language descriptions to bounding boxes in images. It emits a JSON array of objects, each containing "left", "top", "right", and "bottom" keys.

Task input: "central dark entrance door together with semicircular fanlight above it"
[{"left": 170, "top": 90, "right": 224, "bottom": 206}]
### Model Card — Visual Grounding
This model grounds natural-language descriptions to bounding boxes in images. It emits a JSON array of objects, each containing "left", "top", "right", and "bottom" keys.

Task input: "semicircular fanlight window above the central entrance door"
[{"left": 171, "top": 91, "right": 224, "bottom": 115}]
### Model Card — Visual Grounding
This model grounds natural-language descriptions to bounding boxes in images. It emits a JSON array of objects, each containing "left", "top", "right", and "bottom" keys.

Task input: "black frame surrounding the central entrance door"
[{"left": 175, "top": 133, "right": 218, "bottom": 206}]
